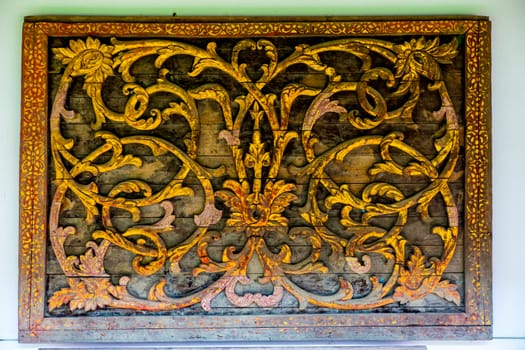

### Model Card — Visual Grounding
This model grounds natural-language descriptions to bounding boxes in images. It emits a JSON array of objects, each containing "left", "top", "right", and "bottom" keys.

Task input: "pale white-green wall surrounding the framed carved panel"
[{"left": 0, "top": 0, "right": 525, "bottom": 350}]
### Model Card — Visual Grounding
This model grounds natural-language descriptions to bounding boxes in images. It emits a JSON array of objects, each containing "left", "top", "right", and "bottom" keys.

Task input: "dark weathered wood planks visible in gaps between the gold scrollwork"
[{"left": 46, "top": 32, "right": 465, "bottom": 317}]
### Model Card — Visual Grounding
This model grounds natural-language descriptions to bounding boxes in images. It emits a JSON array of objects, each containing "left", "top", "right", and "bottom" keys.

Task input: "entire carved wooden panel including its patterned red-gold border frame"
[{"left": 20, "top": 18, "right": 491, "bottom": 342}]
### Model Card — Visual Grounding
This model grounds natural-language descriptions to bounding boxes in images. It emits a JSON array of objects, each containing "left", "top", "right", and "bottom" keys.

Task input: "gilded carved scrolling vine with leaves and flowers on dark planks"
[{"left": 49, "top": 38, "right": 460, "bottom": 311}]
